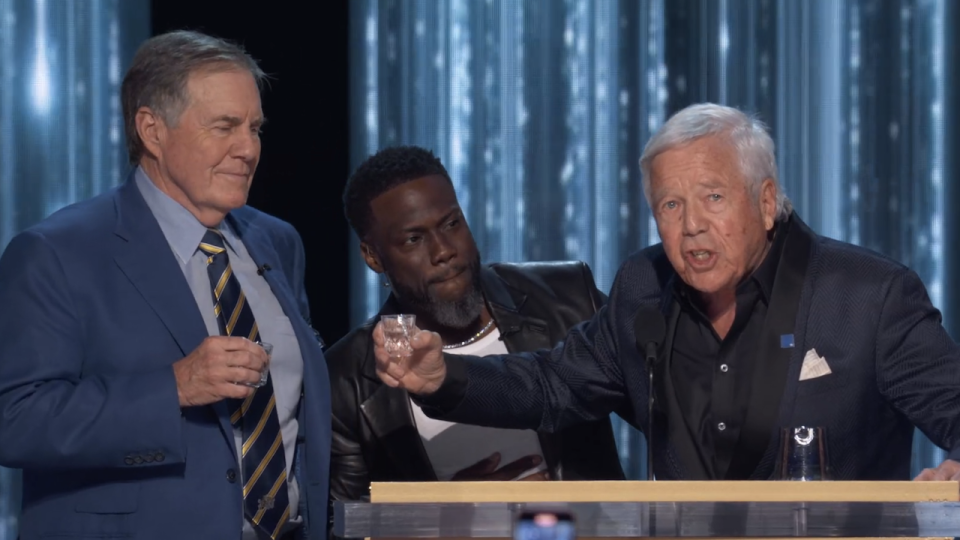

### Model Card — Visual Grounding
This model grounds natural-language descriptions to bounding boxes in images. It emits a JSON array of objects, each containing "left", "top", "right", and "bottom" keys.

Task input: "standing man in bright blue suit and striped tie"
[{"left": 0, "top": 32, "right": 330, "bottom": 540}]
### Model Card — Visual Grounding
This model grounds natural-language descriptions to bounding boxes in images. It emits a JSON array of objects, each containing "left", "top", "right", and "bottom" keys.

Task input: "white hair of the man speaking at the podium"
[{"left": 640, "top": 103, "right": 793, "bottom": 220}]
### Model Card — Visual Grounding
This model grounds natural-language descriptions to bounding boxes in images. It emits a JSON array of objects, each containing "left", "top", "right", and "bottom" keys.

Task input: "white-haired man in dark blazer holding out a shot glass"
[{"left": 374, "top": 104, "right": 960, "bottom": 480}]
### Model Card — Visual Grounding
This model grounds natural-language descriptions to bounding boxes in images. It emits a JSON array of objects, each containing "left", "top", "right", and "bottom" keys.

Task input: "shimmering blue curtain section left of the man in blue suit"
[{"left": 0, "top": 0, "right": 150, "bottom": 540}]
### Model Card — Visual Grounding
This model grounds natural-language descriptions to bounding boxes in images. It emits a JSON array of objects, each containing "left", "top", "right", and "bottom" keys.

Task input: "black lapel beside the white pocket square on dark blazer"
[{"left": 727, "top": 215, "right": 812, "bottom": 478}]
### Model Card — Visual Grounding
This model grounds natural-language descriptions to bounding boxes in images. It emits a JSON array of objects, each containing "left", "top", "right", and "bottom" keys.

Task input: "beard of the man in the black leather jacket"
[{"left": 391, "top": 257, "right": 483, "bottom": 330}]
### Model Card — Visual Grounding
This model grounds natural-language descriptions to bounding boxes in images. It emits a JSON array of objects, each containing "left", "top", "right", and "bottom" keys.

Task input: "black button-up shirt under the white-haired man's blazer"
[{"left": 669, "top": 227, "right": 786, "bottom": 480}]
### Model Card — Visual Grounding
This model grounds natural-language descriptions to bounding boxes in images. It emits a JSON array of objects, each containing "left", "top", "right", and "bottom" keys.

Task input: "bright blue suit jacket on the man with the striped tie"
[{"left": 0, "top": 177, "right": 330, "bottom": 540}]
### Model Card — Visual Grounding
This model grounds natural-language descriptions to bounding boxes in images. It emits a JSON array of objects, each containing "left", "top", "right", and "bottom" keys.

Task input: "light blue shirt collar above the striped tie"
[{"left": 134, "top": 167, "right": 236, "bottom": 264}]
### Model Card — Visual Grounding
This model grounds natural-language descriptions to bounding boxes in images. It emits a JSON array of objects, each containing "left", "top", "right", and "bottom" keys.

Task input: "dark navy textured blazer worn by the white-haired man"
[{"left": 421, "top": 214, "right": 960, "bottom": 480}]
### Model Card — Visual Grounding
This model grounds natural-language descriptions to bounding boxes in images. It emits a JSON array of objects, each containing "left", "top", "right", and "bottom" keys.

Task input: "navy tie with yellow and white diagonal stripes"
[{"left": 200, "top": 229, "right": 290, "bottom": 539}]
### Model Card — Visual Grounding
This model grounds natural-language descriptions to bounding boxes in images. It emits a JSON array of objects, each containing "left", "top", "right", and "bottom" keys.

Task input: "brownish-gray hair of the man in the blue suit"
[{"left": 120, "top": 30, "right": 267, "bottom": 164}]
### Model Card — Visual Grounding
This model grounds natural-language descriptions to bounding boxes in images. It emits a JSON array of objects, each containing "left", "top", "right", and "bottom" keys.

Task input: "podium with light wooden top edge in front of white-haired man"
[{"left": 334, "top": 481, "right": 960, "bottom": 539}]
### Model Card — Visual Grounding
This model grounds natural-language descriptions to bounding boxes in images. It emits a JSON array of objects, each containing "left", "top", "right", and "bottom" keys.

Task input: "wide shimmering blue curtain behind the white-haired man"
[{"left": 350, "top": 0, "right": 960, "bottom": 478}]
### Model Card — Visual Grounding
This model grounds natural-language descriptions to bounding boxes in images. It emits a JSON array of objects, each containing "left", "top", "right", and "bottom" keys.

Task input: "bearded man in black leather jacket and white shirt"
[{"left": 325, "top": 147, "right": 623, "bottom": 512}]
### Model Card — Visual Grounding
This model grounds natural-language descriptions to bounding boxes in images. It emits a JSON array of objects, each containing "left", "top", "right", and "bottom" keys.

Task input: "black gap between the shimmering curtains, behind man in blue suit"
[{"left": 150, "top": 0, "right": 352, "bottom": 344}]
